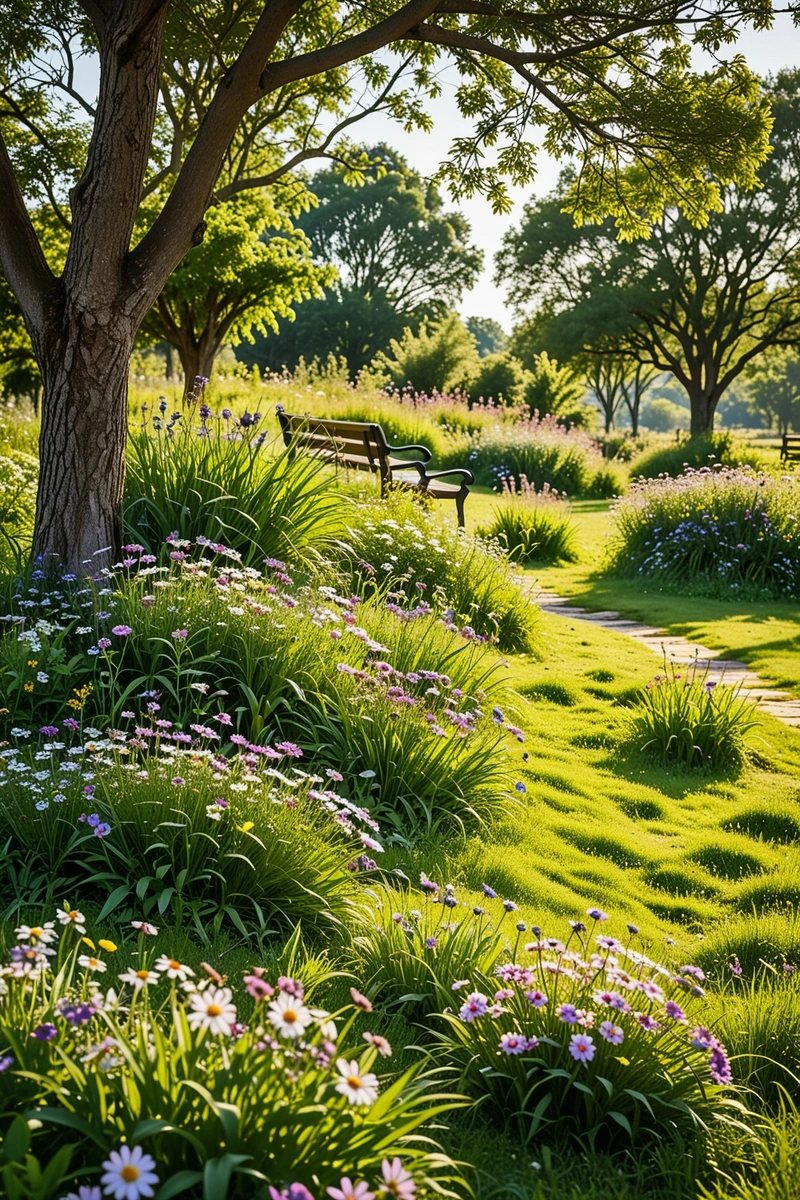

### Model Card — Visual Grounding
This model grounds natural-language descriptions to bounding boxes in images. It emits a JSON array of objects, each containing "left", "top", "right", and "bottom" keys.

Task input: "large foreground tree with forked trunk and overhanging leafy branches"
[{"left": 0, "top": 0, "right": 770, "bottom": 568}]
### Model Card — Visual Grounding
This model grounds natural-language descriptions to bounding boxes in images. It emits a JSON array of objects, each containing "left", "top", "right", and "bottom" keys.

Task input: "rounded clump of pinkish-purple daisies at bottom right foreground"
[{"left": 424, "top": 908, "right": 739, "bottom": 1145}]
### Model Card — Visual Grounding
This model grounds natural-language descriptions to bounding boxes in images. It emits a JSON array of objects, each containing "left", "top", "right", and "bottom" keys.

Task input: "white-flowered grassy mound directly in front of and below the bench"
[{"left": 336, "top": 493, "right": 537, "bottom": 650}]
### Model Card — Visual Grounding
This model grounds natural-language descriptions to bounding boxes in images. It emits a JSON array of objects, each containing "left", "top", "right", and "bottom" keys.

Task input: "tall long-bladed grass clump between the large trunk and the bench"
[{"left": 125, "top": 402, "right": 342, "bottom": 564}]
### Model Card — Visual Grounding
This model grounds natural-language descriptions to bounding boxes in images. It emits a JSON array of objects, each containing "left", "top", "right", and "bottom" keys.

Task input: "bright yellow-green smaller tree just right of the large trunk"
[{"left": 142, "top": 188, "right": 335, "bottom": 392}]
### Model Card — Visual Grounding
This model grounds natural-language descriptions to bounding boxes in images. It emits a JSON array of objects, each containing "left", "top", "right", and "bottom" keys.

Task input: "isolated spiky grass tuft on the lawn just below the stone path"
[{"left": 628, "top": 662, "right": 758, "bottom": 770}]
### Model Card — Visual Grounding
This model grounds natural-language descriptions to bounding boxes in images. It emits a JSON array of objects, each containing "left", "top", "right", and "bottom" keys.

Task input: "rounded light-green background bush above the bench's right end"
[{"left": 369, "top": 312, "right": 480, "bottom": 392}]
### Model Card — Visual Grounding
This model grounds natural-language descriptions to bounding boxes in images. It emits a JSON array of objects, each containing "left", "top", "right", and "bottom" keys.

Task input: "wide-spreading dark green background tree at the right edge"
[{"left": 498, "top": 71, "right": 800, "bottom": 434}]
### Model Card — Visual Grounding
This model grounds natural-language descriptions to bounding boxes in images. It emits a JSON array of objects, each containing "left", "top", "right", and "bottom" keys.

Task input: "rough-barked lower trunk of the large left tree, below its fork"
[{"left": 34, "top": 319, "right": 134, "bottom": 575}]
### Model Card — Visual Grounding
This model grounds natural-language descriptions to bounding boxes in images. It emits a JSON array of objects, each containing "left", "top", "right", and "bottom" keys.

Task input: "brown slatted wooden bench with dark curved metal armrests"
[{"left": 276, "top": 404, "right": 474, "bottom": 529}]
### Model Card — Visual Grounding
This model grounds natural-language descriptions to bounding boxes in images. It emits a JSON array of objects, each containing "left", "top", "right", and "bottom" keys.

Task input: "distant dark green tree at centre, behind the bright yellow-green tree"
[{"left": 243, "top": 145, "right": 483, "bottom": 376}]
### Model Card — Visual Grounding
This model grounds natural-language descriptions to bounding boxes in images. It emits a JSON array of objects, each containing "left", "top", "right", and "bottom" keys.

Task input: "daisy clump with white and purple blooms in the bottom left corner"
[{"left": 0, "top": 908, "right": 457, "bottom": 1200}]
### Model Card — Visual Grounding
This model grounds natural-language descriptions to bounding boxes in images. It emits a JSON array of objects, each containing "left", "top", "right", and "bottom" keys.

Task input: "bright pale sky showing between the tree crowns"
[{"left": 356, "top": 14, "right": 800, "bottom": 331}]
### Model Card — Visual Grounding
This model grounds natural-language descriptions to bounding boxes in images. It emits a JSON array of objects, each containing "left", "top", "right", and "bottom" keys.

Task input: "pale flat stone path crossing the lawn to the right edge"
[{"left": 536, "top": 592, "right": 800, "bottom": 727}]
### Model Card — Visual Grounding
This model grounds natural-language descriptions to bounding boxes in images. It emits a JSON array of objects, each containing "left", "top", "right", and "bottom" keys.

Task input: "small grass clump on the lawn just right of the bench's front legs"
[{"left": 479, "top": 475, "right": 578, "bottom": 563}]
